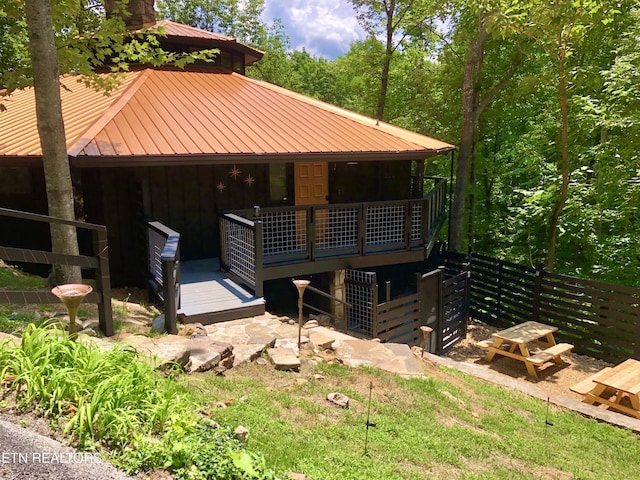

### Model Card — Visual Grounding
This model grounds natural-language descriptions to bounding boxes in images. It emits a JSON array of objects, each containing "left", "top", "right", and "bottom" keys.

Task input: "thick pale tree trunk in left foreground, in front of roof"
[{"left": 25, "top": 0, "right": 81, "bottom": 284}]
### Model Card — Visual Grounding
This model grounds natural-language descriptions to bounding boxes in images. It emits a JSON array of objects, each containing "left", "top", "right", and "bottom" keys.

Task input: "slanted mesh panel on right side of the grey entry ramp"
[{"left": 220, "top": 217, "right": 256, "bottom": 286}]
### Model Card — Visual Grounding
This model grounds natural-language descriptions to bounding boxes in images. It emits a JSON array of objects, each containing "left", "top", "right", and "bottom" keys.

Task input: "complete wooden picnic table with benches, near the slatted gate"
[{"left": 478, "top": 321, "right": 573, "bottom": 378}]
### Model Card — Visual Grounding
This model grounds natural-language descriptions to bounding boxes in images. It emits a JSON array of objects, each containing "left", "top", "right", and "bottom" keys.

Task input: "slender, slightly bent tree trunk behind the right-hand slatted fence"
[{"left": 547, "top": 53, "right": 570, "bottom": 272}]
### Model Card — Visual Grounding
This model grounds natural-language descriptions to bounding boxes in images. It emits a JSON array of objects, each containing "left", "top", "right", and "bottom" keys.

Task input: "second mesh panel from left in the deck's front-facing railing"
[{"left": 316, "top": 207, "right": 358, "bottom": 250}]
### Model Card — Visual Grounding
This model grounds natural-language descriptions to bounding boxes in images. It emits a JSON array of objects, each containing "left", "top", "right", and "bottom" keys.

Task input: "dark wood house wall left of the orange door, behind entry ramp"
[{"left": 82, "top": 165, "right": 268, "bottom": 285}]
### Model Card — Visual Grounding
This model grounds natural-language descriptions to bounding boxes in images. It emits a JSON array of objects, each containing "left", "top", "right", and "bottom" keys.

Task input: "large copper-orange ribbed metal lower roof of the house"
[{"left": 0, "top": 68, "right": 454, "bottom": 166}]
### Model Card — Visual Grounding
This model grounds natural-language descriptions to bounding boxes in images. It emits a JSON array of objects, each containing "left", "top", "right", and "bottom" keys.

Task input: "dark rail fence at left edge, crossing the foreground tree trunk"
[{"left": 0, "top": 208, "right": 114, "bottom": 336}]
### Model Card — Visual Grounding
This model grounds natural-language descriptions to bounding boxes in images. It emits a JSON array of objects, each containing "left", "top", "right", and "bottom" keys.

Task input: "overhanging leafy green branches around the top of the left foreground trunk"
[{"left": 0, "top": 0, "right": 218, "bottom": 92}]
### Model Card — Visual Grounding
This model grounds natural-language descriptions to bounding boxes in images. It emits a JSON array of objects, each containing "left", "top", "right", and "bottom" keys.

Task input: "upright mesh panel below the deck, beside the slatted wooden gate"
[{"left": 345, "top": 270, "right": 378, "bottom": 336}]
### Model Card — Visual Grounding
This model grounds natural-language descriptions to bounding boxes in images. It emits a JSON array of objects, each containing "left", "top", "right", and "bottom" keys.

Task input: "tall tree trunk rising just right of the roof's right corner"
[{"left": 449, "top": 18, "right": 488, "bottom": 252}]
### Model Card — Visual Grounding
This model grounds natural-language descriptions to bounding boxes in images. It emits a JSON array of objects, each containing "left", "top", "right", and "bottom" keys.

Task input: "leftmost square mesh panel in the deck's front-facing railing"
[{"left": 260, "top": 210, "right": 307, "bottom": 257}]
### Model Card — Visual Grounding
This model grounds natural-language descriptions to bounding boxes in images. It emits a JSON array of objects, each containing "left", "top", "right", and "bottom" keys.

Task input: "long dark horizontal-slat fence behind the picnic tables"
[{"left": 444, "top": 252, "right": 640, "bottom": 363}]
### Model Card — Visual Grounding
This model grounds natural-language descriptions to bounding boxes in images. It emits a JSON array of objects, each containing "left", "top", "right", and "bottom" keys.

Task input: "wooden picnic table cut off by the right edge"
[{"left": 583, "top": 358, "right": 640, "bottom": 418}]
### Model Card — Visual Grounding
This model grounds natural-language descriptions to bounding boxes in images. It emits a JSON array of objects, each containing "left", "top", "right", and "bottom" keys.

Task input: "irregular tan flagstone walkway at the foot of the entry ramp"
[{"left": 79, "top": 313, "right": 424, "bottom": 377}]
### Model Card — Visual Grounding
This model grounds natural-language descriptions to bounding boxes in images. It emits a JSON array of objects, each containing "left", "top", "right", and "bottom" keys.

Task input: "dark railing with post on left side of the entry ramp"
[{"left": 147, "top": 221, "right": 180, "bottom": 335}]
